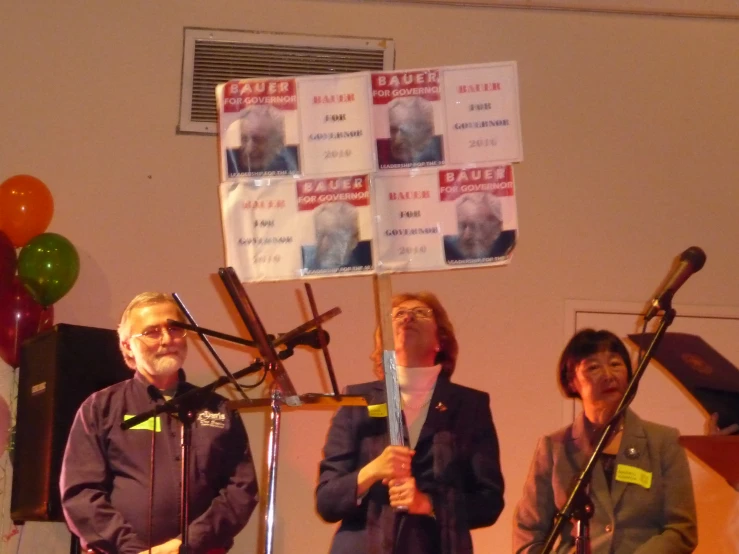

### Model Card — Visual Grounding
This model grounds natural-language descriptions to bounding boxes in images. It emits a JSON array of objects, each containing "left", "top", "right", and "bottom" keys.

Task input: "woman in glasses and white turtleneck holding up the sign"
[{"left": 316, "top": 292, "right": 503, "bottom": 554}]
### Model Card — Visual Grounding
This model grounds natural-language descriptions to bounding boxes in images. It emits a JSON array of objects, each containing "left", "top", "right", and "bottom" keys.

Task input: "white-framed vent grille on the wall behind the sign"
[{"left": 179, "top": 28, "right": 395, "bottom": 134}]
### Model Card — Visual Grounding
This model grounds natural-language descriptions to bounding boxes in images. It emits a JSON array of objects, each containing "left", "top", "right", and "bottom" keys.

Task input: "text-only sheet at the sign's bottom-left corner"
[{"left": 219, "top": 178, "right": 300, "bottom": 282}]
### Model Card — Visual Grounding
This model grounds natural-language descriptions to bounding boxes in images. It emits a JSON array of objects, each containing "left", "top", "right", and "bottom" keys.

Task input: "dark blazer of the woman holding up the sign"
[{"left": 316, "top": 375, "right": 503, "bottom": 554}]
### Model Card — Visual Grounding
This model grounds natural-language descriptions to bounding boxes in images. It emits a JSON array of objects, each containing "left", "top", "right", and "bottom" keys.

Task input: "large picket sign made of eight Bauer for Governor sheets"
[{"left": 216, "top": 62, "right": 523, "bottom": 281}]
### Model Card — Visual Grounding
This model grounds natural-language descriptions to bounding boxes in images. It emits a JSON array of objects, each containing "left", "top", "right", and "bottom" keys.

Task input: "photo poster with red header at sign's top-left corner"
[{"left": 216, "top": 78, "right": 301, "bottom": 181}]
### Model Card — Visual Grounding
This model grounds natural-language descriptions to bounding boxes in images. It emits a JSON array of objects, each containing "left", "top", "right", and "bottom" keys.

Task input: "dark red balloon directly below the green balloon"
[{"left": 0, "top": 278, "right": 54, "bottom": 367}]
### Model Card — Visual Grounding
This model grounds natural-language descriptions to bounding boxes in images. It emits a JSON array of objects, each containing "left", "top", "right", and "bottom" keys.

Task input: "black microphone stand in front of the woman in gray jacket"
[{"left": 542, "top": 302, "right": 676, "bottom": 554}]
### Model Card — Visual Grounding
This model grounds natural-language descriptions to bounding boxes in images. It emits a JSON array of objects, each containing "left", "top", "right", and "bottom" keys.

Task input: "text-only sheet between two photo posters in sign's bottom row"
[{"left": 374, "top": 169, "right": 445, "bottom": 273}]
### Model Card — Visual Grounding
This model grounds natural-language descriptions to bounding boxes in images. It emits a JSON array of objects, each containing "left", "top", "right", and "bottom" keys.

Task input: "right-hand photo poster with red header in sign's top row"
[{"left": 371, "top": 69, "right": 445, "bottom": 170}]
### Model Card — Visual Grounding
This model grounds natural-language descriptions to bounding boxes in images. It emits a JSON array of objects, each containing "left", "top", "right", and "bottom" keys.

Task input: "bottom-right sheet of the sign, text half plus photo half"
[{"left": 374, "top": 165, "right": 518, "bottom": 272}]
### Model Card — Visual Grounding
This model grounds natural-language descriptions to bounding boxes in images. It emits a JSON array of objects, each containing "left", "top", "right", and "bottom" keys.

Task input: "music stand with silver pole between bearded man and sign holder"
[{"left": 218, "top": 267, "right": 367, "bottom": 554}]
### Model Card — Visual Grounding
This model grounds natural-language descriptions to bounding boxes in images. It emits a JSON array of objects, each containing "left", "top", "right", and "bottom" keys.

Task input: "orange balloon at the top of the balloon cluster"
[{"left": 0, "top": 175, "right": 54, "bottom": 248}]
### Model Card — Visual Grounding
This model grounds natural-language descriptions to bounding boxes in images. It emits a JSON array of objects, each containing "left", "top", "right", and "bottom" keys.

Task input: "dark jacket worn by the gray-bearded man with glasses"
[{"left": 60, "top": 372, "right": 257, "bottom": 554}]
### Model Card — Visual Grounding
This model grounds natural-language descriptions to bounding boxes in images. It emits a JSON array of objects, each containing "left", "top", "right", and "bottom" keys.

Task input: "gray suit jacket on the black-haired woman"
[{"left": 513, "top": 410, "right": 698, "bottom": 554}]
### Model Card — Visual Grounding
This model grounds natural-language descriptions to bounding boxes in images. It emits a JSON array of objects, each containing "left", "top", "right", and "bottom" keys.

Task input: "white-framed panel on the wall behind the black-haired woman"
[{"left": 562, "top": 300, "right": 739, "bottom": 554}]
